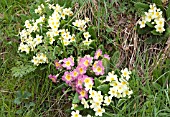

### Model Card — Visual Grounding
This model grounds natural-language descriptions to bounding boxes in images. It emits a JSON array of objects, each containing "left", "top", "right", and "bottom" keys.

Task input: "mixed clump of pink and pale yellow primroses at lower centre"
[{"left": 49, "top": 49, "right": 133, "bottom": 117}]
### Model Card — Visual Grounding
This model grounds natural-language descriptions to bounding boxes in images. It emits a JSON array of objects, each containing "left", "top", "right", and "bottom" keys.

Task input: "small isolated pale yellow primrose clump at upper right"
[{"left": 138, "top": 4, "right": 165, "bottom": 33}]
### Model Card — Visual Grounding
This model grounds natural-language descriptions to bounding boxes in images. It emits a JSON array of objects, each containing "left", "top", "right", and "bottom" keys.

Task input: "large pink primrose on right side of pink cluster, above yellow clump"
[{"left": 92, "top": 60, "right": 104, "bottom": 75}]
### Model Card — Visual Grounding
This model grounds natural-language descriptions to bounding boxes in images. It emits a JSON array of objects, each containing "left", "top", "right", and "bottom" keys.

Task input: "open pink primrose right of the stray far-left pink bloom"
[{"left": 62, "top": 71, "right": 74, "bottom": 85}]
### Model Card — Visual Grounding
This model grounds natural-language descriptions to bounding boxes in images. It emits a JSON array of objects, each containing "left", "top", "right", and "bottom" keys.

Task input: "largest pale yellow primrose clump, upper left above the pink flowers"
[{"left": 18, "top": 1, "right": 92, "bottom": 66}]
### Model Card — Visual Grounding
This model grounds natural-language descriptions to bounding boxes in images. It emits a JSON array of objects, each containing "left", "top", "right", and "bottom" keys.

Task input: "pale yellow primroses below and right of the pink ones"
[{"left": 71, "top": 68, "right": 133, "bottom": 117}]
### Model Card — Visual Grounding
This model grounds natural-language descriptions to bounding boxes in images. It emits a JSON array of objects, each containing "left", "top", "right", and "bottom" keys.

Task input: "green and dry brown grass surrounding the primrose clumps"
[{"left": 0, "top": 0, "right": 170, "bottom": 117}]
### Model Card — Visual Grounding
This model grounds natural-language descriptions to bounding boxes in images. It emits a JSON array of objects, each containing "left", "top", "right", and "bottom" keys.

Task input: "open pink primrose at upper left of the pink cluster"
[{"left": 62, "top": 57, "right": 74, "bottom": 70}]
